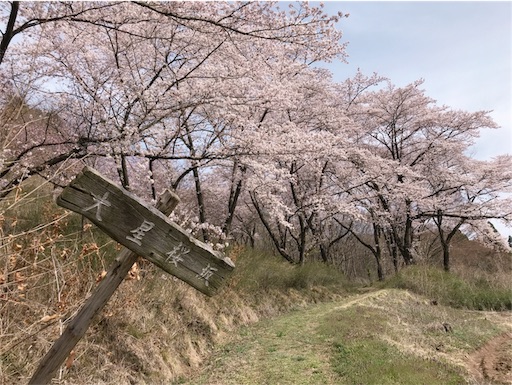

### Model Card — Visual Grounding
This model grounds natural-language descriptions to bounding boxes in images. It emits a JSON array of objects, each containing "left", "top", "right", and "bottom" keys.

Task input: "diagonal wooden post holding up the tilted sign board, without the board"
[{"left": 29, "top": 190, "right": 179, "bottom": 385}]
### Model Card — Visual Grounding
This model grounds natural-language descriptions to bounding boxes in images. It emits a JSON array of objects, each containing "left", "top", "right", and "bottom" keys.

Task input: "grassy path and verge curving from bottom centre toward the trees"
[{"left": 185, "top": 290, "right": 510, "bottom": 385}]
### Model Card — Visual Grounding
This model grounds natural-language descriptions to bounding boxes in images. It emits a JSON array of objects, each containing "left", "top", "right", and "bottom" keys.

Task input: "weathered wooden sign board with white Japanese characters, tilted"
[{"left": 57, "top": 168, "right": 234, "bottom": 295}]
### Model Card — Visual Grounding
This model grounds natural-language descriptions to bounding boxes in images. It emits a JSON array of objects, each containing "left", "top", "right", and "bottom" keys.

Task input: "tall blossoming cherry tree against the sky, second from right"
[{"left": 342, "top": 81, "right": 502, "bottom": 264}]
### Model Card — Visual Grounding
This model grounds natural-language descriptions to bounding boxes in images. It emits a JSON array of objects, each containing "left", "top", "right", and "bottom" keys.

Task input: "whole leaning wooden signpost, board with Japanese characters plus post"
[{"left": 29, "top": 167, "right": 235, "bottom": 385}]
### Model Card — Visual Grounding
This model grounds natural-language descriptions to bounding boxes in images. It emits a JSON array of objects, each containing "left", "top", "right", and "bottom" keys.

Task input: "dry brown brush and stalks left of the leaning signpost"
[{"left": 0, "top": 185, "right": 118, "bottom": 384}]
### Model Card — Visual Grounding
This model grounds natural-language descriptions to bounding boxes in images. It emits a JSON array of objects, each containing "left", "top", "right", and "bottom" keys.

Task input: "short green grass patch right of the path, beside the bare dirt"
[{"left": 318, "top": 306, "right": 464, "bottom": 385}]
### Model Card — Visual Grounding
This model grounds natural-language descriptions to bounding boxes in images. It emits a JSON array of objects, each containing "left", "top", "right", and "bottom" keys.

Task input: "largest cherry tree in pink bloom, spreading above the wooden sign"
[{"left": 4, "top": 3, "right": 344, "bottom": 229}]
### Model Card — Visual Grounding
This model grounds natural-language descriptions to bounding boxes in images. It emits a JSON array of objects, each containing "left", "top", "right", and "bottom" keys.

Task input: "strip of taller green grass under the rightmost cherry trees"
[{"left": 383, "top": 266, "right": 512, "bottom": 311}]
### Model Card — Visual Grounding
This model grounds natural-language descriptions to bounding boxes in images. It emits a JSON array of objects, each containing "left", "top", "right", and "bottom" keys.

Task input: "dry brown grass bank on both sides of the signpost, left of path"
[{"left": 0, "top": 184, "right": 348, "bottom": 385}]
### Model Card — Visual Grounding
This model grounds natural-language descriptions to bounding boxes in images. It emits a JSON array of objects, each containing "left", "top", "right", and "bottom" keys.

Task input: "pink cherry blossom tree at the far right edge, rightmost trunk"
[{"left": 419, "top": 155, "right": 512, "bottom": 271}]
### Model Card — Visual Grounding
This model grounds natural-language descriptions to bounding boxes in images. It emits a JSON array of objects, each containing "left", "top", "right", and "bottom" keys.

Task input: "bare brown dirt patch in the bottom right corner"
[{"left": 469, "top": 332, "right": 512, "bottom": 384}]
